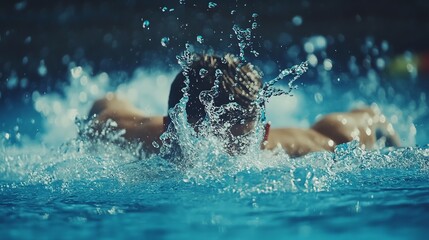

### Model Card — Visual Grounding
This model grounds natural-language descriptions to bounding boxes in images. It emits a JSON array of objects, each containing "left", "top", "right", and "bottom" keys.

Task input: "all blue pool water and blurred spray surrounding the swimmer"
[{"left": 0, "top": 1, "right": 429, "bottom": 239}]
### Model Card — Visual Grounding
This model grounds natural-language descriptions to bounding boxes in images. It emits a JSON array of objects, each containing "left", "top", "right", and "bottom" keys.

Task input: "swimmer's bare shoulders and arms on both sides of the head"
[{"left": 89, "top": 94, "right": 400, "bottom": 157}]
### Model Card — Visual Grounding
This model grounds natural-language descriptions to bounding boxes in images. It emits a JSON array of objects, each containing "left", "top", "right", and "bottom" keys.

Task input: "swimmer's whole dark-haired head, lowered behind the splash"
[{"left": 168, "top": 54, "right": 262, "bottom": 154}]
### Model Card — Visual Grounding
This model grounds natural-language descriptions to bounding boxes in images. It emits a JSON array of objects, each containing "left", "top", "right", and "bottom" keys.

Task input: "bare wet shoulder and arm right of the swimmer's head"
[{"left": 266, "top": 108, "right": 400, "bottom": 156}]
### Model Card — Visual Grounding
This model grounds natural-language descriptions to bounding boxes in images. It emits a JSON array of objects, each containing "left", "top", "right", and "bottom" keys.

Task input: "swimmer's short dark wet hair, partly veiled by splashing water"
[{"left": 168, "top": 54, "right": 262, "bottom": 123}]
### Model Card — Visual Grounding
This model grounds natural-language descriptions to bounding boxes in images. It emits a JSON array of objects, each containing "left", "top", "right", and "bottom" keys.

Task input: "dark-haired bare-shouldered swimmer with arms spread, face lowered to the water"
[{"left": 89, "top": 54, "right": 400, "bottom": 157}]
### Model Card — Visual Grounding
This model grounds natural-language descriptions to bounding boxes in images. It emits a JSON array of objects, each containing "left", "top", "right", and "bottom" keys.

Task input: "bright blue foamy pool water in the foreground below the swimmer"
[{"left": 0, "top": 142, "right": 429, "bottom": 239}]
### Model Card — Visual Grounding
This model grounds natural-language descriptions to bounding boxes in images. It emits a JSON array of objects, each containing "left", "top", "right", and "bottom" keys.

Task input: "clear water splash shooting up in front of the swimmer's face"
[{"left": 150, "top": 44, "right": 308, "bottom": 184}]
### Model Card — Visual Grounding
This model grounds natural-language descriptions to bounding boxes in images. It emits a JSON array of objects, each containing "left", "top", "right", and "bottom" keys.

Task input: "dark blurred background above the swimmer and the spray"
[{"left": 0, "top": 0, "right": 429, "bottom": 139}]
